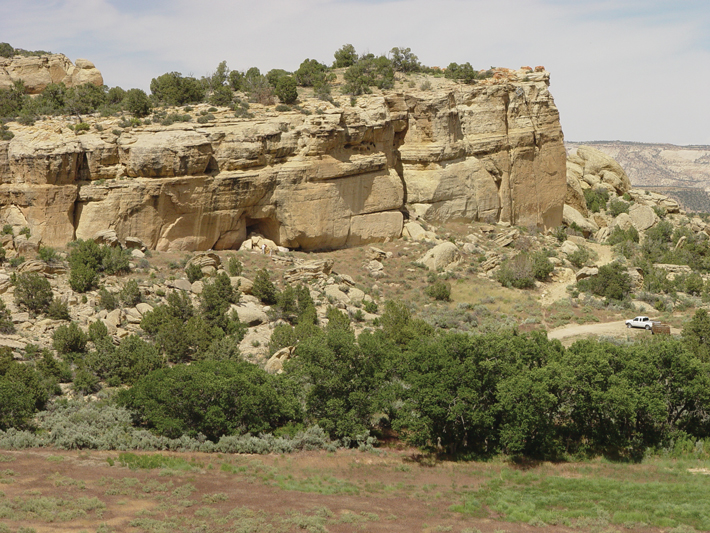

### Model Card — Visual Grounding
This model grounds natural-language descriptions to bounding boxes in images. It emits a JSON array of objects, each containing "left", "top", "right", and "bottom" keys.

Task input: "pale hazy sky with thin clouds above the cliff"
[{"left": 0, "top": 0, "right": 710, "bottom": 144}]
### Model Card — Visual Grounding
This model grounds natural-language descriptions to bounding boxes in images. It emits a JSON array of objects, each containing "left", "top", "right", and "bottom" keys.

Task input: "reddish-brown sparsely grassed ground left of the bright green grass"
[{"left": 0, "top": 449, "right": 608, "bottom": 533}]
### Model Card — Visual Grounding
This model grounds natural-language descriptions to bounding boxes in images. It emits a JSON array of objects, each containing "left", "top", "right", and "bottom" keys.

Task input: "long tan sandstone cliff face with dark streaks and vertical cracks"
[{"left": 0, "top": 71, "right": 566, "bottom": 250}]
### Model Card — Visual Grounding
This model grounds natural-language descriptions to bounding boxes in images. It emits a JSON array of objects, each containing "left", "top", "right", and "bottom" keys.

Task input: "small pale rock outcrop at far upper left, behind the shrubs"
[{"left": 0, "top": 54, "right": 104, "bottom": 94}]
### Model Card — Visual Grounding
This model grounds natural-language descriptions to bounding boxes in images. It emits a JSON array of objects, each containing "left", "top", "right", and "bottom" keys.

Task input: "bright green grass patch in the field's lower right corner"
[{"left": 452, "top": 464, "right": 710, "bottom": 531}]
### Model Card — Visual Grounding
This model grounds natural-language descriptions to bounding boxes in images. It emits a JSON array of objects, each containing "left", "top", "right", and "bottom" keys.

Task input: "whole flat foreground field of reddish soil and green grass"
[{"left": 0, "top": 450, "right": 710, "bottom": 533}]
